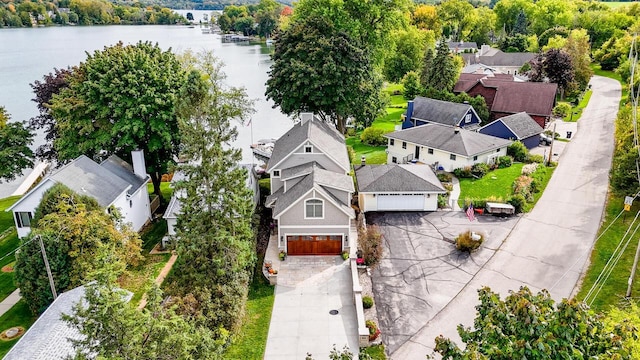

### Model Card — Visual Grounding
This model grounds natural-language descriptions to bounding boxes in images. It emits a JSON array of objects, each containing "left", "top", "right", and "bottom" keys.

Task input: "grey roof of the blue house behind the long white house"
[{"left": 411, "top": 96, "right": 472, "bottom": 126}]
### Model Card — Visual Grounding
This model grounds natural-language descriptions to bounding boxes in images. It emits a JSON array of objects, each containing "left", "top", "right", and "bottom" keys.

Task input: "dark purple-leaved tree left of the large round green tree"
[{"left": 29, "top": 68, "right": 73, "bottom": 161}]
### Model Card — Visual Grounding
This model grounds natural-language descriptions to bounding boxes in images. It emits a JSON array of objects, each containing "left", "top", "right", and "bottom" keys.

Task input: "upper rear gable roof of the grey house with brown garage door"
[{"left": 267, "top": 116, "right": 350, "bottom": 170}]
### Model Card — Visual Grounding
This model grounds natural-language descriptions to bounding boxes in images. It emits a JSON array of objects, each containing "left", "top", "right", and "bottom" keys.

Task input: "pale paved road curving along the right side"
[{"left": 391, "top": 76, "right": 620, "bottom": 360}]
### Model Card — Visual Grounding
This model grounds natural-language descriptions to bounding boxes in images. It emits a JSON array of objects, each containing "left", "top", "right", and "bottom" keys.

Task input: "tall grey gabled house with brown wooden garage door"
[{"left": 265, "top": 113, "right": 355, "bottom": 255}]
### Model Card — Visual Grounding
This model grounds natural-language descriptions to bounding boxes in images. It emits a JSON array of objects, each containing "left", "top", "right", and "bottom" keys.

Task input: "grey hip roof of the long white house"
[{"left": 385, "top": 123, "right": 511, "bottom": 157}]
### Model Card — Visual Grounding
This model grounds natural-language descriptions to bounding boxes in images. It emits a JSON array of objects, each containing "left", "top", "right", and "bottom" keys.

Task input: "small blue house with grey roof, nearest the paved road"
[{"left": 480, "top": 112, "right": 543, "bottom": 149}]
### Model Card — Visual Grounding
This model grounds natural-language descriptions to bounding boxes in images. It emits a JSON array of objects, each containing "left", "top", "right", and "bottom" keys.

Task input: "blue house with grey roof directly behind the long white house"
[{"left": 402, "top": 96, "right": 481, "bottom": 130}]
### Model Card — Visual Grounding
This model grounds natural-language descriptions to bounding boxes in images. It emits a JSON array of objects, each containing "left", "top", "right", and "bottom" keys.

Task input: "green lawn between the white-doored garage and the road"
[{"left": 458, "top": 163, "right": 524, "bottom": 206}]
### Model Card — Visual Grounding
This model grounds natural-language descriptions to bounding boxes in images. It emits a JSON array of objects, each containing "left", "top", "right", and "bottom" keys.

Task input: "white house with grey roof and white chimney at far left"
[{"left": 7, "top": 150, "right": 151, "bottom": 238}]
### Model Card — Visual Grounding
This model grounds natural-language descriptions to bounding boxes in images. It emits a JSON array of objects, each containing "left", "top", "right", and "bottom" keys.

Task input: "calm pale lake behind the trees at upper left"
[{"left": 0, "top": 19, "right": 293, "bottom": 198}]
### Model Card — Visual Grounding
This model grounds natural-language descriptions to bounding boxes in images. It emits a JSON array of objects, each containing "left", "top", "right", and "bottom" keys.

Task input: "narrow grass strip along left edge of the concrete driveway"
[{"left": 224, "top": 273, "right": 275, "bottom": 359}]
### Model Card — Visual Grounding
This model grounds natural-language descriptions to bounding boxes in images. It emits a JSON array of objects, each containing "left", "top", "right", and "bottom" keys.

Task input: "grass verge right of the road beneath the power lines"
[{"left": 577, "top": 196, "right": 640, "bottom": 311}]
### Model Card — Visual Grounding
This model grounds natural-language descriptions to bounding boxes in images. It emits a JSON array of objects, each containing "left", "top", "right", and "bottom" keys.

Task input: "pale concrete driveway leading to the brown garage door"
[{"left": 264, "top": 256, "right": 358, "bottom": 360}]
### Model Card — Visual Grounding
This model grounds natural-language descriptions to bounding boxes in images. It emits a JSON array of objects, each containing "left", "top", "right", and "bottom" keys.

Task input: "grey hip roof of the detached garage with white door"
[{"left": 356, "top": 164, "right": 446, "bottom": 193}]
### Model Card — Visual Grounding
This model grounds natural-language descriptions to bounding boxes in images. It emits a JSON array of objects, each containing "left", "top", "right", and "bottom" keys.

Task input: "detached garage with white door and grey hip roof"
[{"left": 355, "top": 164, "right": 447, "bottom": 212}]
